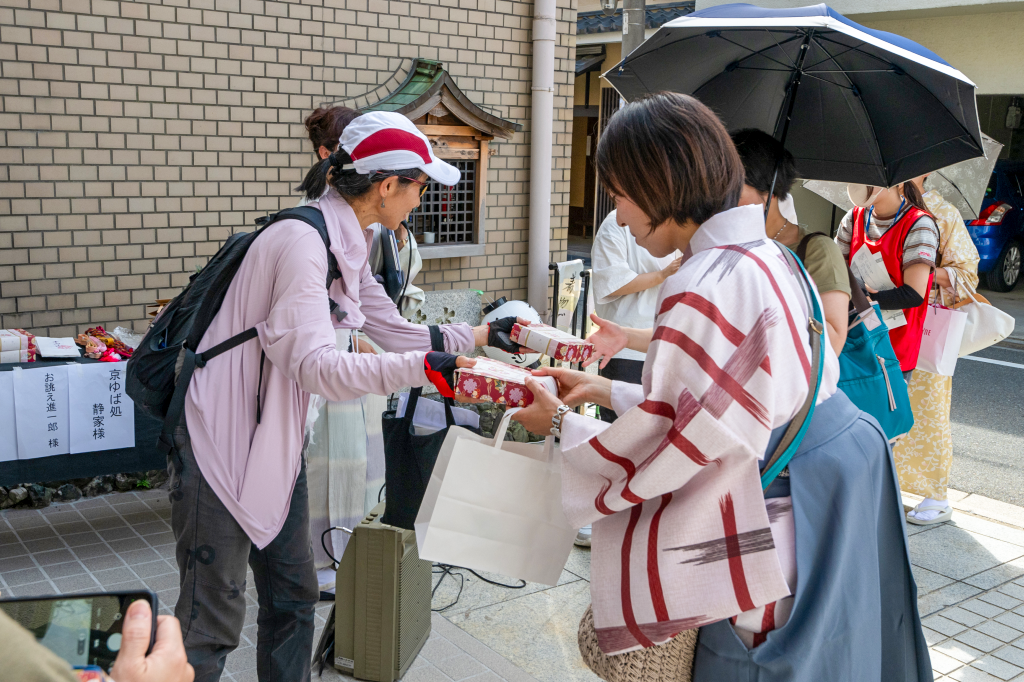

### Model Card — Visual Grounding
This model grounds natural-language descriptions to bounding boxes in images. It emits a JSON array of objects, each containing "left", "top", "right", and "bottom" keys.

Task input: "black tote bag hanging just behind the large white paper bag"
[{"left": 381, "top": 326, "right": 479, "bottom": 530}]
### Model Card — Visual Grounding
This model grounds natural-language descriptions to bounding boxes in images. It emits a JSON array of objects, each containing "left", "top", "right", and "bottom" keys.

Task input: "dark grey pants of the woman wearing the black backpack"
[{"left": 167, "top": 425, "right": 319, "bottom": 682}]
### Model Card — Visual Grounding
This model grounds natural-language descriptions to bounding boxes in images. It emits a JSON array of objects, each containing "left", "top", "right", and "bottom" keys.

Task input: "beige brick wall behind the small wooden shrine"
[{"left": 0, "top": 0, "right": 577, "bottom": 335}]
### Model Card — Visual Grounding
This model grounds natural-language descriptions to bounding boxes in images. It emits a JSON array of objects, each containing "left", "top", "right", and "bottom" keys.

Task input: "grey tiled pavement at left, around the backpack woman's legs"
[{"left": 0, "top": 489, "right": 536, "bottom": 682}]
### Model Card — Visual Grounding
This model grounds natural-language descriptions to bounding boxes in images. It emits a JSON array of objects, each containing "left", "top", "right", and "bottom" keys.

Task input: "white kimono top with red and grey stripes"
[{"left": 561, "top": 206, "right": 839, "bottom": 653}]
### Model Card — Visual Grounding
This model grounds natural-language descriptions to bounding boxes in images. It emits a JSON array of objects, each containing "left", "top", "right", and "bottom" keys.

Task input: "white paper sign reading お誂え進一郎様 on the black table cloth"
[{"left": 11, "top": 365, "right": 71, "bottom": 460}]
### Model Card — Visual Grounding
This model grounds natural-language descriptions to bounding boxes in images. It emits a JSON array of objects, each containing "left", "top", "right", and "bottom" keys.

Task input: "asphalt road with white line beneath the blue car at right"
[{"left": 950, "top": 342, "right": 1024, "bottom": 505}]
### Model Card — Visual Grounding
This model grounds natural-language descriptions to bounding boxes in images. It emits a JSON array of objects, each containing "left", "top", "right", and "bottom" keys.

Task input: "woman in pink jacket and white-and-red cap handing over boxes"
[{"left": 169, "top": 112, "right": 515, "bottom": 682}]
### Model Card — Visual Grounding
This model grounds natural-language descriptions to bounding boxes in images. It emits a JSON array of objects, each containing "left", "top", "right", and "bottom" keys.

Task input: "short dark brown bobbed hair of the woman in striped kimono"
[{"left": 597, "top": 92, "right": 743, "bottom": 231}]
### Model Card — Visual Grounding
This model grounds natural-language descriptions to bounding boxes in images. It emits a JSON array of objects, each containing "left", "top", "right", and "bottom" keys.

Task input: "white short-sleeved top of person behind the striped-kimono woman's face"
[{"left": 591, "top": 211, "right": 679, "bottom": 360}]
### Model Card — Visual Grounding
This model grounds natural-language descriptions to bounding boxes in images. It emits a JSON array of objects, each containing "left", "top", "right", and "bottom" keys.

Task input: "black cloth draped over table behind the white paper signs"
[{"left": 0, "top": 357, "right": 167, "bottom": 486}]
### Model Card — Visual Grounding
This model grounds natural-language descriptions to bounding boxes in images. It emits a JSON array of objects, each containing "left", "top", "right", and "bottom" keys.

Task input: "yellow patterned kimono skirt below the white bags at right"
[{"left": 893, "top": 370, "right": 953, "bottom": 500}]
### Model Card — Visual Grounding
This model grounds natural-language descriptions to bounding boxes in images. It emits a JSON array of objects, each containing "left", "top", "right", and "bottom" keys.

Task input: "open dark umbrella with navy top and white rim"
[{"left": 604, "top": 4, "right": 984, "bottom": 187}]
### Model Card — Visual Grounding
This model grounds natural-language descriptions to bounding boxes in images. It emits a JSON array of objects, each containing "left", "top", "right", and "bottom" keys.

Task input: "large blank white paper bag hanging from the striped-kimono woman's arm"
[{"left": 415, "top": 409, "right": 577, "bottom": 585}]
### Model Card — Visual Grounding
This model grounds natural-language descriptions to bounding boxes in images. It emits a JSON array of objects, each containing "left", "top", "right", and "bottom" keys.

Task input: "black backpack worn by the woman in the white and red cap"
[{"left": 125, "top": 206, "right": 346, "bottom": 454}]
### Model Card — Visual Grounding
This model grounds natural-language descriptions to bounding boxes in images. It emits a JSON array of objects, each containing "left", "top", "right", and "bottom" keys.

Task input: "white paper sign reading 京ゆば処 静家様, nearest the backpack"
[{"left": 68, "top": 363, "right": 135, "bottom": 455}]
